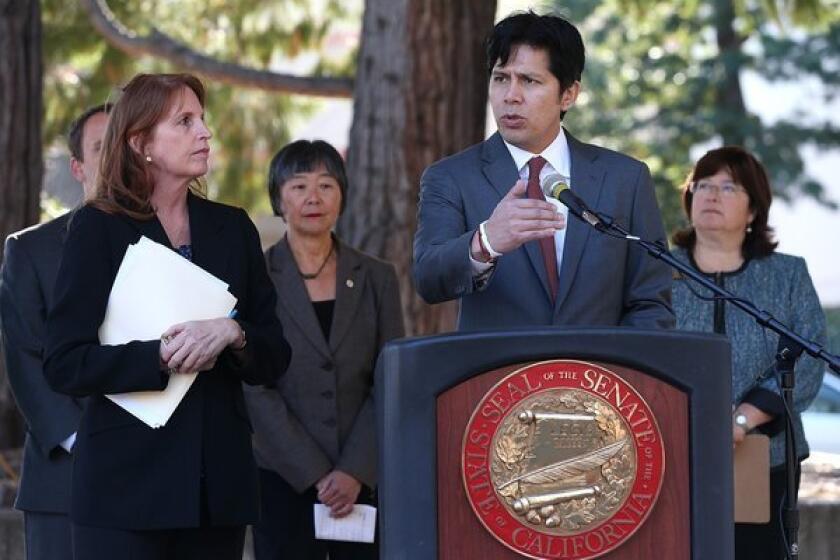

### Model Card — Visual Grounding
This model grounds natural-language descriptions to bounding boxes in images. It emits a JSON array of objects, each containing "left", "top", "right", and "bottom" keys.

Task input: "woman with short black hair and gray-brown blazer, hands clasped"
[{"left": 245, "top": 140, "right": 404, "bottom": 560}]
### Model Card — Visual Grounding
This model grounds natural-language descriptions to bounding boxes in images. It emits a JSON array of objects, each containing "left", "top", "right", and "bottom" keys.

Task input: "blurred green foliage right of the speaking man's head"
[{"left": 553, "top": 0, "right": 840, "bottom": 231}]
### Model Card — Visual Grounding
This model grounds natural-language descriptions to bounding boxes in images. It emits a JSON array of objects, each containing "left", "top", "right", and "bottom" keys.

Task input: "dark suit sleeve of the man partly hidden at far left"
[{"left": 0, "top": 233, "right": 81, "bottom": 456}]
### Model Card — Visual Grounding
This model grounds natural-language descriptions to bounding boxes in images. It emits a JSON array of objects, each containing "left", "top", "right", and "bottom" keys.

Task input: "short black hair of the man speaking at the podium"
[{"left": 487, "top": 11, "right": 586, "bottom": 91}]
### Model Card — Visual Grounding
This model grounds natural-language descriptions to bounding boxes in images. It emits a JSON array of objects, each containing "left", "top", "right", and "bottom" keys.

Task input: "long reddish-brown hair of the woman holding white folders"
[{"left": 88, "top": 70, "right": 205, "bottom": 220}]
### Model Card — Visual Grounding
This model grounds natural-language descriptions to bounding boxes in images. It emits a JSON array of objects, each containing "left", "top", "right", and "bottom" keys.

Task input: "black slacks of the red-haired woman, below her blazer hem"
[{"left": 73, "top": 523, "right": 245, "bottom": 560}]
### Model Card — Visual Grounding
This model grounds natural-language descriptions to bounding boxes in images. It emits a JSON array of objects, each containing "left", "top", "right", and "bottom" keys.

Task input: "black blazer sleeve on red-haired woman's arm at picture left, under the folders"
[{"left": 44, "top": 207, "right": 168, "bottom": 396}]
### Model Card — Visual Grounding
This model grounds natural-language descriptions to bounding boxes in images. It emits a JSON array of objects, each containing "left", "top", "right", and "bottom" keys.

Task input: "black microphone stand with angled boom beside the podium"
[{"left": 567, "top": 211, "right": 840, "bottom": 560}]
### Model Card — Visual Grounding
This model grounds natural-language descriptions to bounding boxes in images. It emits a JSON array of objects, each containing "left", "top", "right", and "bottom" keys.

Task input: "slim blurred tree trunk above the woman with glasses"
[{"left": 714, "top": 0, "right": 747, "bottom": 146}]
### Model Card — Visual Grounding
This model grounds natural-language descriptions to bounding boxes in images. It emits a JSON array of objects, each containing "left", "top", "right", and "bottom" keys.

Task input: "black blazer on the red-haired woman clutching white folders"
[{"left": 45, "top": 195, "right": 290, "bottom": 529}]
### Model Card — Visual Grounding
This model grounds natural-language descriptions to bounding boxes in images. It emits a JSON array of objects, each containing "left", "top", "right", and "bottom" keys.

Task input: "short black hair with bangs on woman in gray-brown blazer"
[{"left": 268, "top": 140, "right": 347, "bottom": 217}]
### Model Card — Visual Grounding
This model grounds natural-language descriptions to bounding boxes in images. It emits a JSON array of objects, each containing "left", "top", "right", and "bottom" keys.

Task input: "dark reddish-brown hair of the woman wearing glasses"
[{"left": 671, "top": 146, "right": 778, "bottom": 259}]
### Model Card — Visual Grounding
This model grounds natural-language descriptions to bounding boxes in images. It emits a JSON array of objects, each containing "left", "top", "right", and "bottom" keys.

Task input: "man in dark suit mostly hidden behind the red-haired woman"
[{"left": 0, "top": 105, "right": 108, "bottom": 560}]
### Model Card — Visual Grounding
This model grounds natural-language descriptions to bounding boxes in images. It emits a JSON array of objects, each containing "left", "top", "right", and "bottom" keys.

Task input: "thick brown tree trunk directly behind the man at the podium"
[{"left": 340, "top": 0, "right": 496, "bottom": 335}]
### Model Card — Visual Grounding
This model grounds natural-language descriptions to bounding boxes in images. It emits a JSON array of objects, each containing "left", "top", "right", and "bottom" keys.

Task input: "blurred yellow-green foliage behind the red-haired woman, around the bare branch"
[{"left": 41, "top": 0, "right": 361, "bottom": 210}]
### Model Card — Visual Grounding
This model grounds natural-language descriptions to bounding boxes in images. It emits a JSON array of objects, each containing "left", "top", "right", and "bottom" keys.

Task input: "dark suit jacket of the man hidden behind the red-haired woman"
[{"left": 0, "top": 214, "right": 82, "bottom": 513}]
